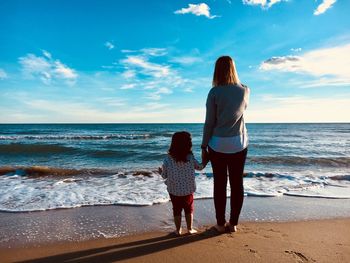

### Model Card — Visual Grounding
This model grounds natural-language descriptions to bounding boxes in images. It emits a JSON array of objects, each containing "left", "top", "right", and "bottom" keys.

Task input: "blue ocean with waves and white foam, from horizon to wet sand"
[{"left": 0, "top": 123, "right": 350, "bottom": 212}]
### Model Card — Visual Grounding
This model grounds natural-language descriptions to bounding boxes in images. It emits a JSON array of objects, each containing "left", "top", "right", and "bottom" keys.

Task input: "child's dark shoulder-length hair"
[{"left": 168, "top": 131, "right": 192, "bottom": 162}]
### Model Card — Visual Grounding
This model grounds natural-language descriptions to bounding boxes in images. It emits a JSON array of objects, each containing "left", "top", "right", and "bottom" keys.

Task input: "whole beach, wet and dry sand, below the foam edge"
[{"left": 0, "top": 197, "right": 350, "bottom": 262}]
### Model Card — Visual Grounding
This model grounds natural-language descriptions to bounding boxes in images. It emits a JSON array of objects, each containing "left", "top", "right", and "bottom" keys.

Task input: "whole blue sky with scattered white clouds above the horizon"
[{"left": 0, "top": 0, "right": 350, "bottom": 123}]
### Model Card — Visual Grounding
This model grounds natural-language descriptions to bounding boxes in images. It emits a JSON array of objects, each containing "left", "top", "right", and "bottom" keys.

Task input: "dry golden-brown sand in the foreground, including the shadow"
[{"left": 0, "top": 219, "right": 350, "bottom": 262}]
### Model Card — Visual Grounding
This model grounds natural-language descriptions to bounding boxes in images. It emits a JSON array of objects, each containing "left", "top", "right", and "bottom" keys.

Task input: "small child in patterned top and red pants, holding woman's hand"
[{"left": 160, "top": 131, "right": 209, "bottom": 235}]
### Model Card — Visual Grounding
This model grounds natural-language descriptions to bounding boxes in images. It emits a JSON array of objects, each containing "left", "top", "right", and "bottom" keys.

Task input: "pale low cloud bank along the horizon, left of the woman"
[{"left": 0, "top": 97, "right": 205, "bottom": 123}]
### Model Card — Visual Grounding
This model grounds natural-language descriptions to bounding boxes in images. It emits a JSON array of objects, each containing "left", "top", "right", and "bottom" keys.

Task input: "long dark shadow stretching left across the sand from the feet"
[{"left": 17, "top": 228, "right": 218, "bottom": 263}]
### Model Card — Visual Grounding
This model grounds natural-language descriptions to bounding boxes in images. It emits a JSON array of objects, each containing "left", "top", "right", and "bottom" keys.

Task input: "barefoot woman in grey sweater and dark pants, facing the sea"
[{"left": 201, "top": 56, "right": 249, "bottom": 233}]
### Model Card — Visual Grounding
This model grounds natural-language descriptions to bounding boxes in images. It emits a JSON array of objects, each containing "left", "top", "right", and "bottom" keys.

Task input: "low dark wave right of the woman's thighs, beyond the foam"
[{"left": 247, "top": 156, "right": 350, "bottom": 167}]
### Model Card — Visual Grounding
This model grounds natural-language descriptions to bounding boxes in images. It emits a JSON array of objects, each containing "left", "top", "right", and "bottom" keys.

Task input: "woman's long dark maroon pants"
[{"left": 209, "top": 147, "right": 248, "bottom": 226}]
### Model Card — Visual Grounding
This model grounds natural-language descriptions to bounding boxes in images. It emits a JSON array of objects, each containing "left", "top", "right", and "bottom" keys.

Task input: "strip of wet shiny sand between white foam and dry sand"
[{"left": 0, "top": 196, "right": 350, "bottom": 249}]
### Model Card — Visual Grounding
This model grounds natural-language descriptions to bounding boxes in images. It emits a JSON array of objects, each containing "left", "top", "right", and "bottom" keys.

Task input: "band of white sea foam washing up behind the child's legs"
[{"left": 0, "top": 172, "right": 350, "bottom": 212}]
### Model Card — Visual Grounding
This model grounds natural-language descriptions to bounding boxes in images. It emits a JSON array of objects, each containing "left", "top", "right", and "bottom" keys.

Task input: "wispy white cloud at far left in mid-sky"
[{"left": 18, "top": 50, "right": 78, "bottom": 84}]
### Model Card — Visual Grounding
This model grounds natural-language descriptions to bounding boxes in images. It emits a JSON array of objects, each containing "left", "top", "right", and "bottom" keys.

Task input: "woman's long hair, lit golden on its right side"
[{"left": 212, "top": 56, "right": 240, "bottom": 87}]
